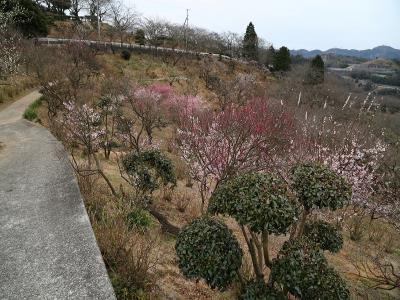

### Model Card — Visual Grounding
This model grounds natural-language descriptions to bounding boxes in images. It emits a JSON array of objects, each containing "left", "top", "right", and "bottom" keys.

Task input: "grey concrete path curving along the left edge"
[{"left": 0, "top": 92, "right": 115, "bottom": 300}]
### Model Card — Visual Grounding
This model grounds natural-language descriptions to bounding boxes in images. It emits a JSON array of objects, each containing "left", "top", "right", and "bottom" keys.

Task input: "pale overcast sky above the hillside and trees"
[{"left": 124, "top": 0, "right": 400, "bottom": 50}]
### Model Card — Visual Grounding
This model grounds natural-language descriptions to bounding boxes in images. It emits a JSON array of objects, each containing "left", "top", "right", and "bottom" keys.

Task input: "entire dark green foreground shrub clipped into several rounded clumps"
[{"left": 176, "top": 162, "right": 351, "bottom": 300}]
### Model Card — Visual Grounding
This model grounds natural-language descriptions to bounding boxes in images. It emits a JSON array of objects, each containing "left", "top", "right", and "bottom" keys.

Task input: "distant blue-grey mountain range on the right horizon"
[{"left": 290, "top": 46, "right": 400, "bottom": 59}]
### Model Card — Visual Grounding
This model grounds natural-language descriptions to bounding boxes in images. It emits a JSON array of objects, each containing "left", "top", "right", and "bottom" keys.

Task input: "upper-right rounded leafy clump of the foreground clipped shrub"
[{"left": 292, "top": 162, "right": 351, "bottom": 210}]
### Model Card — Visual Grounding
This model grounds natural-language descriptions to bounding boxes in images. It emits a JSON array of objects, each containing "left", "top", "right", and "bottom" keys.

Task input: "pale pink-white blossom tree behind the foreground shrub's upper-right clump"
[{"left": 289, "top": 111, "right": 393, "bottom": 229}]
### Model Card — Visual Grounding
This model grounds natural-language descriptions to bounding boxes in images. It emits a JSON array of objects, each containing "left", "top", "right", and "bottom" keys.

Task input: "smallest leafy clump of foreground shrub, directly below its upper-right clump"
[{"left": 304, "top": 220, "right": 343, "bottom": 253}]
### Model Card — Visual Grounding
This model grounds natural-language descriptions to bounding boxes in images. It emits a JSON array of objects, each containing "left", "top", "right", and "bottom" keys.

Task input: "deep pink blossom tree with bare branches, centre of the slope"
[{"left": 177, "top": 99, "right": 292, "bottom": 207}]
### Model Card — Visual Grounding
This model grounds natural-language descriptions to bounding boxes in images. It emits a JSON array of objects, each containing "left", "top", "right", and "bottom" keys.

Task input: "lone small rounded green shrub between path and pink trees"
[{"left": 122, "top": 150, "right": 176, "bottom": 192}]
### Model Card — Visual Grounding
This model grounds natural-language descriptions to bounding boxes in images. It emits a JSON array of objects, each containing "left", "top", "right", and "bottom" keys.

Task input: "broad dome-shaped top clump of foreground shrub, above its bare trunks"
[{"left": 208, "top": 173, "right": 297, "bottom": 234}]
